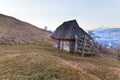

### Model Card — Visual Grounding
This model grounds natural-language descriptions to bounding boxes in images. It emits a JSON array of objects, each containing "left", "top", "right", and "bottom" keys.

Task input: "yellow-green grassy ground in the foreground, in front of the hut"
[{"left": 0, "top": 45, "right": 120, "bottom": 80}]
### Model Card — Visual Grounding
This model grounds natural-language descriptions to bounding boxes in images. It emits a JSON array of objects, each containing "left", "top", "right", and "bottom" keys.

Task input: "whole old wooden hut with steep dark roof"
[{"left": 51, "top": 20, "right": 94, "bottom": 56}]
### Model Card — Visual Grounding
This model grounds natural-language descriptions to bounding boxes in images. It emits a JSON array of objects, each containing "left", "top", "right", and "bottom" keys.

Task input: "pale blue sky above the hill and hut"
[{"left": 0, "top": 0, "right": 120, "bottom": 30}]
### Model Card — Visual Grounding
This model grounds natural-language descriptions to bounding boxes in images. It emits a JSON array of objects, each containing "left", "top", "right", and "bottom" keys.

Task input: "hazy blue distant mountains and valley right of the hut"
[{"left": 93, "top": 28, "right": 120, "bottom": 47}]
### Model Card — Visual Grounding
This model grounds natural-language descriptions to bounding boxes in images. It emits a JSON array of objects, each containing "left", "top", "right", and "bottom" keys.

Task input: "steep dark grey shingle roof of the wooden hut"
[{"left": 51, "top": 20, "right": 91, "bottom": 40}]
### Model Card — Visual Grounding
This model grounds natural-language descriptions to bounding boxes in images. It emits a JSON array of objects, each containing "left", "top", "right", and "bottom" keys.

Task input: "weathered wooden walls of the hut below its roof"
[{"left": 54, "top": 38, "right": 94, "bottom": 56}]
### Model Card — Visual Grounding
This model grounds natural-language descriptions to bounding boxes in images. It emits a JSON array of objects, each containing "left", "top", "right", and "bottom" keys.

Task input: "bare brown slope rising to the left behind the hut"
[{"left": 0, "top": 14, "right": 51, "bottom": 44}]
